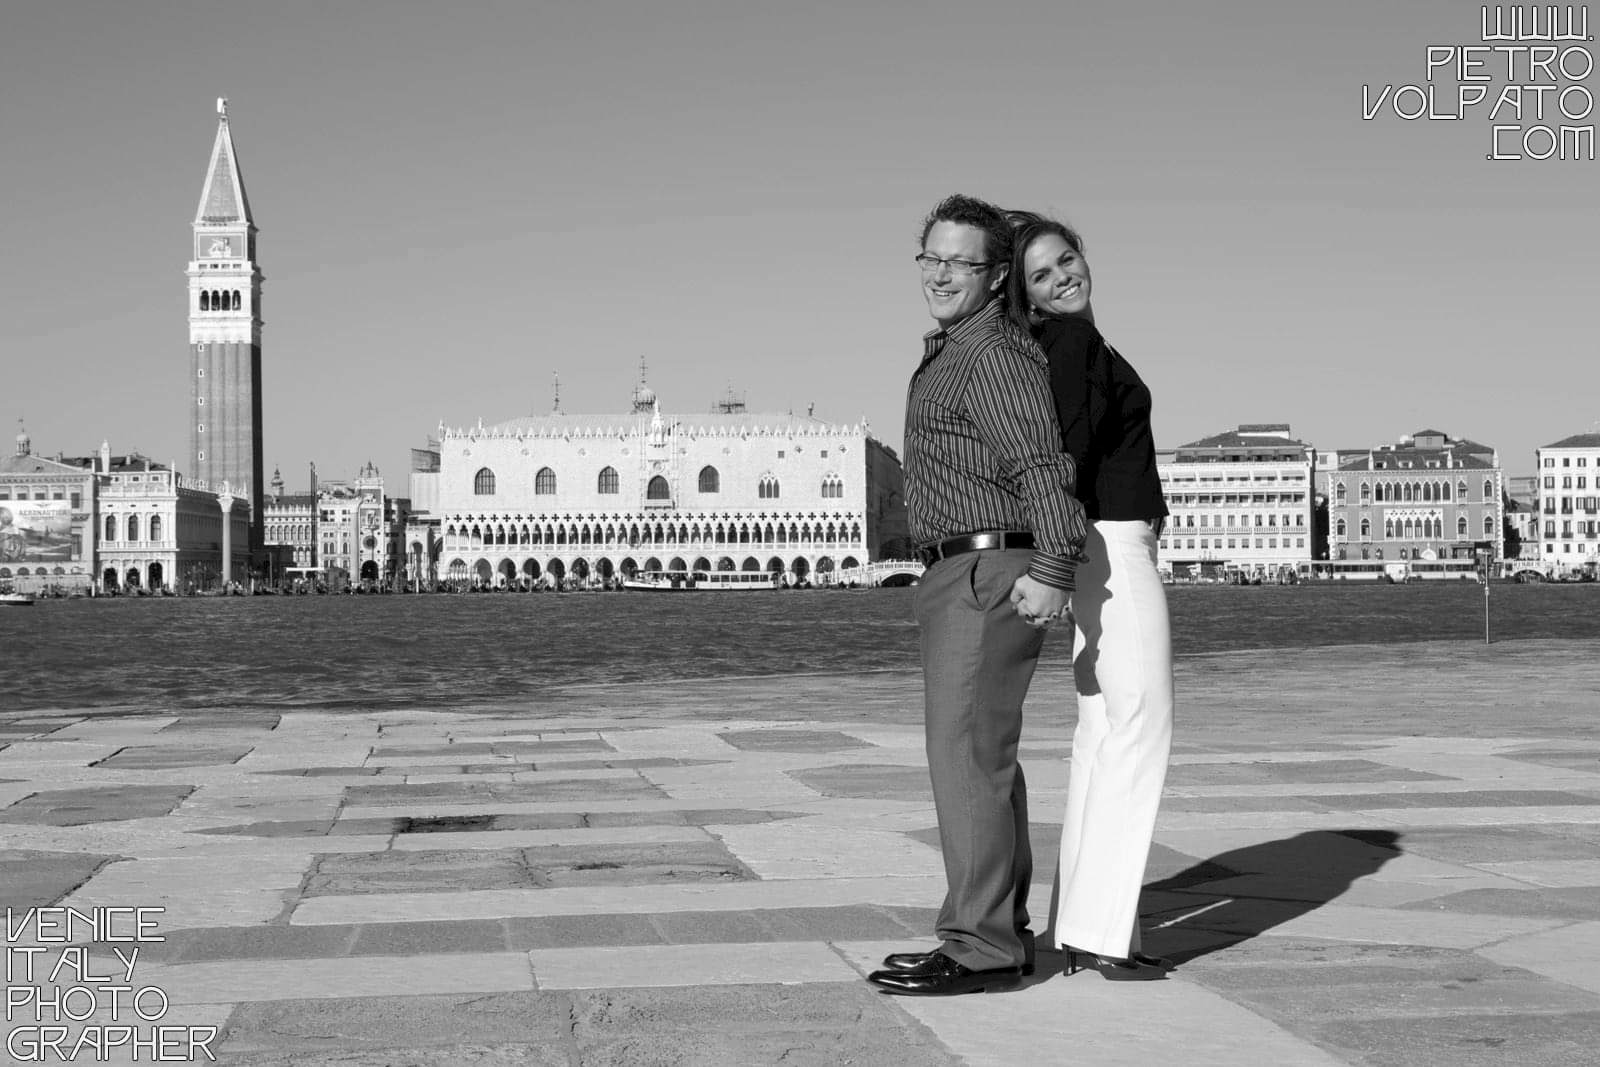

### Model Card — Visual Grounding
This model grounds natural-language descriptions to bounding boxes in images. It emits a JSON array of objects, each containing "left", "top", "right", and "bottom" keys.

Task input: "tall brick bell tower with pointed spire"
[{"left": 187, "top": 99, "right": 264, "bottom": 555}]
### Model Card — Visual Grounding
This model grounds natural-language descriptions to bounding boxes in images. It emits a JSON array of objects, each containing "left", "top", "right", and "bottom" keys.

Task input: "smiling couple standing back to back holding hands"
[{"left": 869, "top": 195, "right": 1173, "bottom": 997}]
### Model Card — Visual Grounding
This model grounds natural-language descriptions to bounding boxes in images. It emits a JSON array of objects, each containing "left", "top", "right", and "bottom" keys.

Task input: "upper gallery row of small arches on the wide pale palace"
[{"left": 445, "top": 523, "right": 861, "bottom": 549}]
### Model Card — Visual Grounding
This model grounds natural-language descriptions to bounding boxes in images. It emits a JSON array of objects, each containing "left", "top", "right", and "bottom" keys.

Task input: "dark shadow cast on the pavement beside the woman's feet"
[{"left": 1139, "top": 830, "right": 1403, "bottom": 963}]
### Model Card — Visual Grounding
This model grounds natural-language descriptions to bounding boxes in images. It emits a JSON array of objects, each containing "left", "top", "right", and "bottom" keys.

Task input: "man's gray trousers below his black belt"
[{"left": 915, "top": 549, "right": 1045, "bottom": 971}]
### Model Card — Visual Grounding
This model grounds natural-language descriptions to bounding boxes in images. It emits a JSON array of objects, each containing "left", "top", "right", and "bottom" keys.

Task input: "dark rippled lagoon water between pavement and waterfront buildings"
[{"left": 0, "top": 582, "right": 1600, "bottom": 712}]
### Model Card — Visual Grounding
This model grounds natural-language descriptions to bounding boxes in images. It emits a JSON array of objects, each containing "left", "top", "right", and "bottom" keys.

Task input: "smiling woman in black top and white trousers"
[{"left": 1006, "top": 213, "right": 1173, "bottom": 981}]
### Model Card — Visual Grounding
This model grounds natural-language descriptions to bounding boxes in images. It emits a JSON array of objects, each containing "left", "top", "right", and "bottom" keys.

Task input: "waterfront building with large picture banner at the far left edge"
[{"left": 0, "top": 429, "right": 94, "bottom": 593}]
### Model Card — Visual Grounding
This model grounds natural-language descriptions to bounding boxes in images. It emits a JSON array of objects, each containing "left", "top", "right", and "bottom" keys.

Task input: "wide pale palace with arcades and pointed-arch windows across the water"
[{"left": 428, "top": 379, "right": 907, "bottom": 585}]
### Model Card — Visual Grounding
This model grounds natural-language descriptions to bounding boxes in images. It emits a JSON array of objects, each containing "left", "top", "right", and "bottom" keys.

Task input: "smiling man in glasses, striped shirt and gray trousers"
[{"left": 869, "top": 195, "right": 1086, "bottom": 997}]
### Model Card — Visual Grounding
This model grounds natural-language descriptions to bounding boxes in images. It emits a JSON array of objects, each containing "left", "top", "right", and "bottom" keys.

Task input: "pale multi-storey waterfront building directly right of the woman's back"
[{"left": 1157, "top": 422, "right": 1315, "bottom": 579}]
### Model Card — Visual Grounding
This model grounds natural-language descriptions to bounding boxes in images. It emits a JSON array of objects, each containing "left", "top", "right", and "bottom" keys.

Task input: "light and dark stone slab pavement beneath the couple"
[{"left": 0, "top": 641, "right": 1600, "bottom": 1067}]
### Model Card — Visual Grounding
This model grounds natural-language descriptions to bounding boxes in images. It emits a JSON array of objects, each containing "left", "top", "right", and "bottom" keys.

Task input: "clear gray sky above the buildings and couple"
[{"left": 0, "top": 0, "right": 1600, "bottom": 494}]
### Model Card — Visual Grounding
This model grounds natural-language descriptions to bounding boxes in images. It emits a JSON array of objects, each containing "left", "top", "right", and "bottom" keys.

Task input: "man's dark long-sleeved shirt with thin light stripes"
[{"left": 906, "top": 301, "right": 1088, "bottom": 589}]
